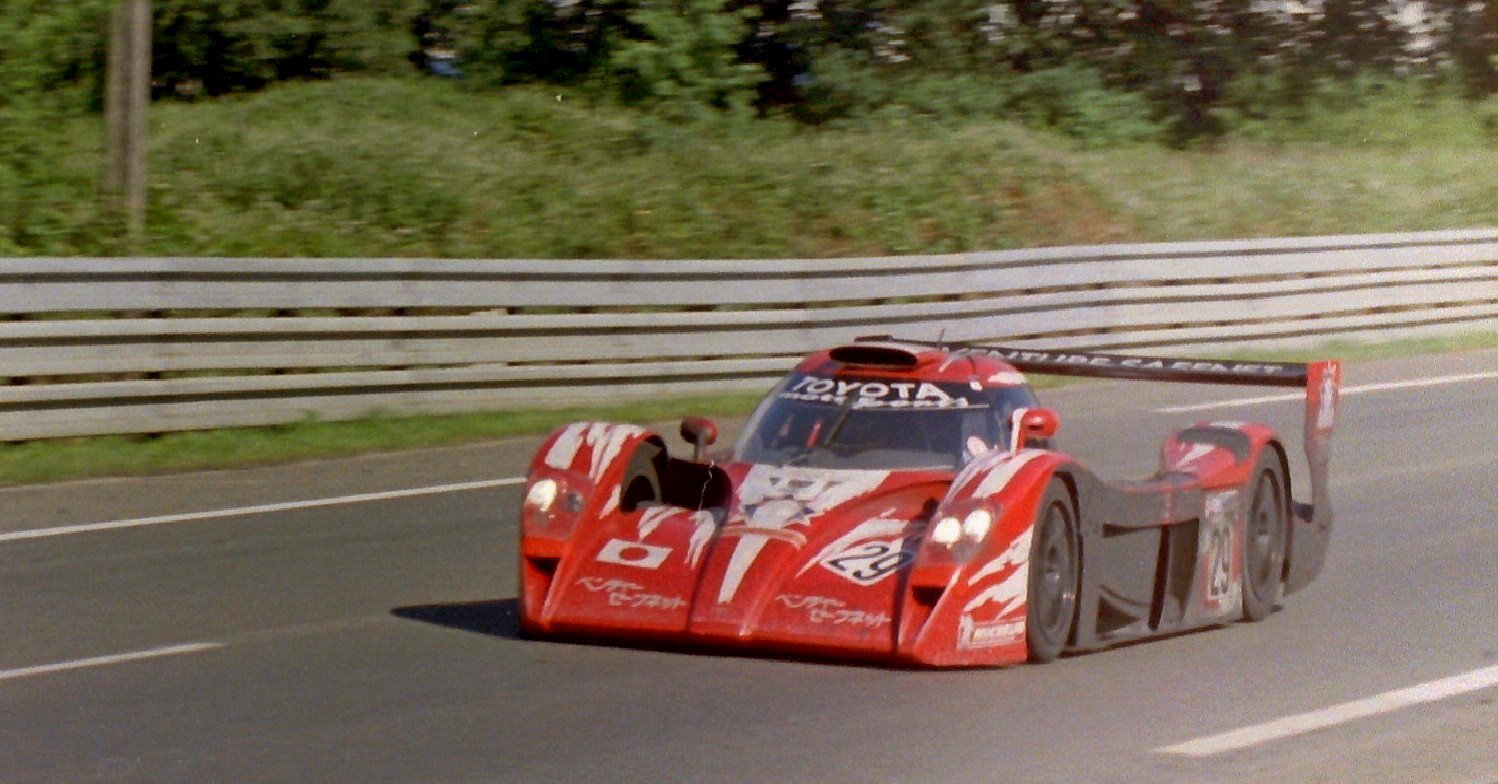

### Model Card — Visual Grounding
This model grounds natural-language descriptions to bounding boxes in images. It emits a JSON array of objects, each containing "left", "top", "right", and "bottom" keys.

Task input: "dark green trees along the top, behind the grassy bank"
[{"left": 14, "top": 0, "right": 1498, "bottom": 139}]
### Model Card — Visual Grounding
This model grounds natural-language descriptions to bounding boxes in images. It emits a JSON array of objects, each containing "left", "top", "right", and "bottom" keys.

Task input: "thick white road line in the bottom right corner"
[{"left": 1155, "top": 666, "right": 1498, "bottom": 757}]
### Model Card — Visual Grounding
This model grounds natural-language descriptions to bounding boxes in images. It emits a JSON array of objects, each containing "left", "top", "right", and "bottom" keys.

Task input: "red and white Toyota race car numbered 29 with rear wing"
[{"left": 520, "top": 336, "right": 1341, "bottom": 667}]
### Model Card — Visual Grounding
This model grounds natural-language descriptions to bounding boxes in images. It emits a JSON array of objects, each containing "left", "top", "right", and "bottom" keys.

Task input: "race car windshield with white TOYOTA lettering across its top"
[{"left": 736, "top": 375, "right": 1035, "bottom": 469}]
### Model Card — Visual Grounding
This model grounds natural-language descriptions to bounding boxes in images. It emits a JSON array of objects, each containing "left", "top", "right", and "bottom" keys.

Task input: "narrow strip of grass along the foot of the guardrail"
[{"left": 0, "top": 333, "right": 1498, "bottom": 484}]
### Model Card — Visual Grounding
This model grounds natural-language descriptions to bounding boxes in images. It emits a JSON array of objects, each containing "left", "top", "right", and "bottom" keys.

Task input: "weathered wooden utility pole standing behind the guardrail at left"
[{"left": 103, "top": 0, "right": 151, "bottom": 238}]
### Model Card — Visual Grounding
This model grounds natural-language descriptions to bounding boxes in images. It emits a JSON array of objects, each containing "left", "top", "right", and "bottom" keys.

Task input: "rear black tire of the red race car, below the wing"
[{"left": 1242, "top": 447, "right": 1290, "bottom": 622}]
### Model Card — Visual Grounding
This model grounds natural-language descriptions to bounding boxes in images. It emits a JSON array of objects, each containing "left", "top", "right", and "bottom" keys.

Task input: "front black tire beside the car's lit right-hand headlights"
[{"left": 1025, "top": 478, "right": 1082, "bottom": 663}]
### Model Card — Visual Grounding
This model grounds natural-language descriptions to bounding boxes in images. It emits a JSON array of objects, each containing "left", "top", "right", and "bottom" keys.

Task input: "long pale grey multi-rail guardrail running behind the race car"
[{"left": 0, "top": 229, "right": 1498, "bottom": 441}]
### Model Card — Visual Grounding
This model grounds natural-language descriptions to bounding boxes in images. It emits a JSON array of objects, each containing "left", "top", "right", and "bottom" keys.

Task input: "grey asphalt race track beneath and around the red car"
[{"left": 0, "top": 351, "right": 1498, "bottom": 784}]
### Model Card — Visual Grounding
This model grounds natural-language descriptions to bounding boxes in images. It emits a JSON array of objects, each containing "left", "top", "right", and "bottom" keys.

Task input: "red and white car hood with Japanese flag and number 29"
[{"left": 544, "top": 465, "right": 951, "bottom": 655}]
